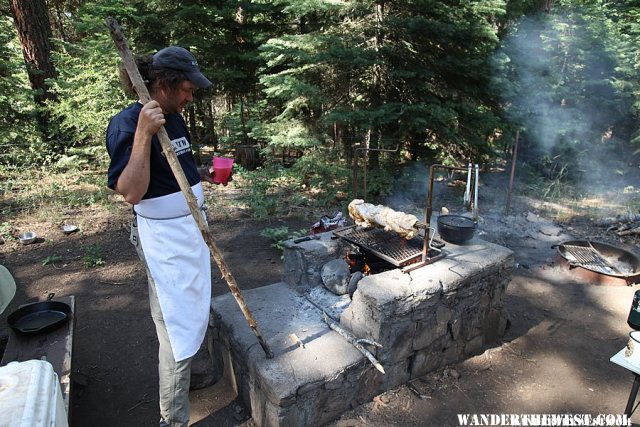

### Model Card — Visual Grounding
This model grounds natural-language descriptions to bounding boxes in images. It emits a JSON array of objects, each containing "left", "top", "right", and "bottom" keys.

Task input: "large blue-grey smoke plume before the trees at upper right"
[{"left": 493, "top": 13, "right": 629, "bottom": 191}]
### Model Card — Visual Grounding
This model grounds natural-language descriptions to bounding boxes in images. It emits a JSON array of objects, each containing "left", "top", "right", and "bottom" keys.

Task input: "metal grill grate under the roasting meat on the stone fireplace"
[{"left": 333, "top": 225, "right": 432, "bottom": 267}]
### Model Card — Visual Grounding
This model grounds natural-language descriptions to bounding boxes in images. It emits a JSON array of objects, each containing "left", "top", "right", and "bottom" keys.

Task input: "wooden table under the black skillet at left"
[{"left": 0, "top": 296, "right": 76, "bottom": 416}]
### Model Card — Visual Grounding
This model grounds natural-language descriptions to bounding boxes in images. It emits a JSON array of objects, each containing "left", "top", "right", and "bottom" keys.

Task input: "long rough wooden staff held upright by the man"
[{"left": 106, "top": 17, "right": 273, "bottom": 359}]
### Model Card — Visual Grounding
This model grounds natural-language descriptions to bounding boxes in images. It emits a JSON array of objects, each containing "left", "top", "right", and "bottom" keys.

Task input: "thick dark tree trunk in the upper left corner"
[{"left": 9, "top": 0, "right": 56, "bottom": 139}]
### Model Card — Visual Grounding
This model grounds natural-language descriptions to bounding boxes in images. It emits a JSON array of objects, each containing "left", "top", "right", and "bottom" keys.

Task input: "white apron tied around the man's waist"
[{"left": 134, "top": 184, "right": 211, "bottom": 362}]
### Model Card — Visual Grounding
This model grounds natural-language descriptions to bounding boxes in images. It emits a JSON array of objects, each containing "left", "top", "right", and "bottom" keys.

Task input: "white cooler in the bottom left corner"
[{"left": 0, "top": 360, "right": 69, "bottom": 427}]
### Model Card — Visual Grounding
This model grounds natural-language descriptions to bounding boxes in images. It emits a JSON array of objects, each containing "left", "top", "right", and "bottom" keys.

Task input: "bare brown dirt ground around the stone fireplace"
[{"left": 0, "top": 171, "right": 640, "bottom": 427}]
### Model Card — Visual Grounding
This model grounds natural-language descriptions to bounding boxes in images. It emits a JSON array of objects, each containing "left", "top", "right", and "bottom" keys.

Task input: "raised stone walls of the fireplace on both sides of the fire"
[{"left": 283, "top": 234, "right": 514, "bottom": 388}]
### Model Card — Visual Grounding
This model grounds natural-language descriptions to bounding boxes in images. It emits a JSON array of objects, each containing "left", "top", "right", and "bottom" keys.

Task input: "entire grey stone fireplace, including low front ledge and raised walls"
[{"left": 211, "top": 232, "right": 514, "bottom": 426}]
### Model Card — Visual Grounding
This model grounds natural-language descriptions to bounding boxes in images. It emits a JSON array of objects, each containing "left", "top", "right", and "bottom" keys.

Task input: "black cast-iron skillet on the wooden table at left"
[{"left": 7, "top": 294, "right": 71, "bottom": 335}]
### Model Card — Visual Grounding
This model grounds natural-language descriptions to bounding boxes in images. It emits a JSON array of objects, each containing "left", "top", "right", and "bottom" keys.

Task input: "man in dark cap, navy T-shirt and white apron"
[{"left": 106, "top": 46, "right": 220, "bottom": 426}]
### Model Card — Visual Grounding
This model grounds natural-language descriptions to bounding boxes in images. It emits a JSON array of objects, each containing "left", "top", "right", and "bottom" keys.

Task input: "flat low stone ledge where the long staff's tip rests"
[{"left": 211, "top": 282, "right": 364, "bottom": 407}]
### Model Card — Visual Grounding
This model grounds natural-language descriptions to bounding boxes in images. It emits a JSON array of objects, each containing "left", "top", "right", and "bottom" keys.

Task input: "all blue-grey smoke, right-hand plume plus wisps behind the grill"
[{"left": 384, "top": 11, "right": 637, "bottom": 217}]
